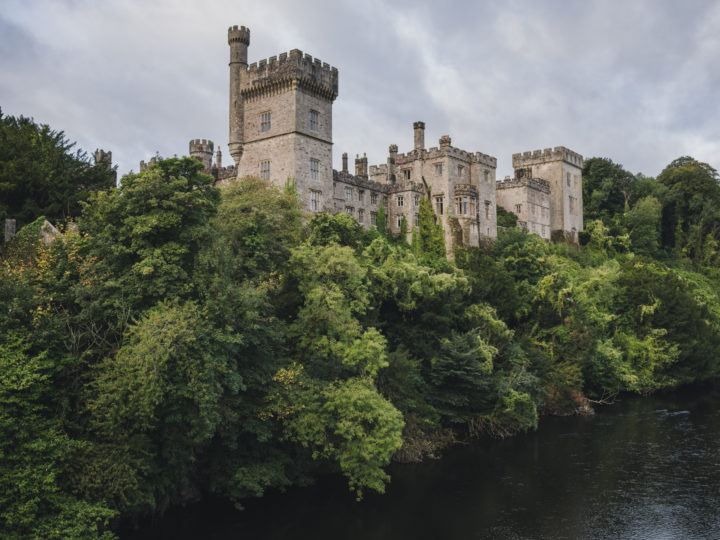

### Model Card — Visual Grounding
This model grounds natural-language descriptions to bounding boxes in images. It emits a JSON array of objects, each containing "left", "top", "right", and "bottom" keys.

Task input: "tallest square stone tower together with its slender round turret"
[{"left": 228, "top": 27, "right": 338, "bottom": 211}]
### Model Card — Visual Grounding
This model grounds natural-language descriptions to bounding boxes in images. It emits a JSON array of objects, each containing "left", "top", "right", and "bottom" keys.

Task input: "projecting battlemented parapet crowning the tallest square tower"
[{"left": 241, "top": 49, "right": 338, "bottom": 100}]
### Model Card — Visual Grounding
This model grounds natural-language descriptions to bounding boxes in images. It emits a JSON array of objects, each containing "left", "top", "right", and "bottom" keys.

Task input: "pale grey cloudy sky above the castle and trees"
[{"left": 0, "top": 0, "right": 720, "bottom": 177}]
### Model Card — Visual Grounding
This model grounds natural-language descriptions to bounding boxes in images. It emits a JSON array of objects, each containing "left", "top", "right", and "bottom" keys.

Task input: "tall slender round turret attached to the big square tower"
[{"left": 228, "top": 26, "right": 250, "bottom": 167}]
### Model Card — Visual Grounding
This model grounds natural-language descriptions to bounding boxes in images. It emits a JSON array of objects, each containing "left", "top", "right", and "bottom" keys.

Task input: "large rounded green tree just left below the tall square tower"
[{"left": 79, "top": 158, "right": 220, "bottom": 310}]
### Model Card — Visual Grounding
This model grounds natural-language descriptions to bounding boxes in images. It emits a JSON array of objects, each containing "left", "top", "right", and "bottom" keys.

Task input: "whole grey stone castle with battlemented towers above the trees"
[{"left": 141, "top": 26, "right": 583, "bottom": 247}]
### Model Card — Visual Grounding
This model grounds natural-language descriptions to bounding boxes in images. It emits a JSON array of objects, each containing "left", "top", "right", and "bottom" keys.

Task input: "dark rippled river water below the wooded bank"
[{"left": 127, "top": 384, "right": 720, "bottom": 540}]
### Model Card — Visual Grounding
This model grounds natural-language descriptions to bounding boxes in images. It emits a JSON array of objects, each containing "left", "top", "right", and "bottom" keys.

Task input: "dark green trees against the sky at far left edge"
[{"left": 0, "top": 110, "right": 115, "bottom": 226}]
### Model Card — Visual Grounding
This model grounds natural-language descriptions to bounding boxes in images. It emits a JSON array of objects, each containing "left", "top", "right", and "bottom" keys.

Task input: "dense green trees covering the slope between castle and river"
[{"left": 0, "top": 120, "right": 720, "bottom": 538}]
